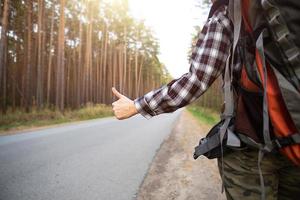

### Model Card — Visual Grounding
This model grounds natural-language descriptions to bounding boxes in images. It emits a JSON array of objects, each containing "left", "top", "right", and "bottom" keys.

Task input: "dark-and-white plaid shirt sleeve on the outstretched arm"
[{"left": 134, "top": 6, "right": 233, "bottom": 119}]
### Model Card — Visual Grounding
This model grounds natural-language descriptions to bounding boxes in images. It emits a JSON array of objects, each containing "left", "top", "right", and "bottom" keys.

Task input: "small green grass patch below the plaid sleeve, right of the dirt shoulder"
[{"left": 187, "top": 105, "right": 220, "bottom": 125}]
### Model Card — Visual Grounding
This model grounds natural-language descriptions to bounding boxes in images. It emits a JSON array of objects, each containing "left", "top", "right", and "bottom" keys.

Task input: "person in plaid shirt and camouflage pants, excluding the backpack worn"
[{"left": 112, "top": 1, "right": 300, "bottom": 200}]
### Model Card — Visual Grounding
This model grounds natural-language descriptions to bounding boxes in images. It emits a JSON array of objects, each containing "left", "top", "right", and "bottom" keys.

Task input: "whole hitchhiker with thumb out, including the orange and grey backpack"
[{"left": 112, "top": 0, "right": 300, "bottom": 200}]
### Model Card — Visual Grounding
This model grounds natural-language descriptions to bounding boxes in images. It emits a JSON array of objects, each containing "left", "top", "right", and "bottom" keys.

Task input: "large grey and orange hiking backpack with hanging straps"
[{"left": 194, "top": 0, "right": 300, "bottom": 199}]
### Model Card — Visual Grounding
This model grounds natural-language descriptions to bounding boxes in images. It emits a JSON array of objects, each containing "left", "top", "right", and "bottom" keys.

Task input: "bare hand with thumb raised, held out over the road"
[{"left": 112, "top": 87, "right": 138, "bottom": 120}]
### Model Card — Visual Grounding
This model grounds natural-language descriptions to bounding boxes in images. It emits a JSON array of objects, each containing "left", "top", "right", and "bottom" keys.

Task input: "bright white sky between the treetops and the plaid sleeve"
[{"left": 129, "top": 0, "right": 208, "bottom": 78}]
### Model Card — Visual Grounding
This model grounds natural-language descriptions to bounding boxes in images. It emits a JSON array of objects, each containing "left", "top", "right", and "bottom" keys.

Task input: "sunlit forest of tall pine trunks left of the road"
[{"left": 0, "top": 0, "right": 170, "bottom": 113}]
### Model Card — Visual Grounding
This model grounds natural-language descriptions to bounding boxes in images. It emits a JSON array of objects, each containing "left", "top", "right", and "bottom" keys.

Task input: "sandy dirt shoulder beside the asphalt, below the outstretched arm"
[{"left": 137, "top": 110, "right": 226, "bottom": 200}]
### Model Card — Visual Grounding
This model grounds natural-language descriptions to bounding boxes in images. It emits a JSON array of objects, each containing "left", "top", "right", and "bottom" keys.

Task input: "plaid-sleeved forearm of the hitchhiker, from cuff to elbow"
[{"left": 134, "top": 66, "right": 219, "bottom": 119}]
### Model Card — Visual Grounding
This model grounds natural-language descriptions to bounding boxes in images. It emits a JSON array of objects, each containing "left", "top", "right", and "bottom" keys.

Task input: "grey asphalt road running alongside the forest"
[{"left": 0, "top": 111, "right": 180, "bottom": 200}]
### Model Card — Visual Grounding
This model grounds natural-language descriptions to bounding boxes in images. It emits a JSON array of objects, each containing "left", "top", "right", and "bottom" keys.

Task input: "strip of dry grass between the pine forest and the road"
[{"left": 0, "top": 104, "right": 113, "bottom": 134}]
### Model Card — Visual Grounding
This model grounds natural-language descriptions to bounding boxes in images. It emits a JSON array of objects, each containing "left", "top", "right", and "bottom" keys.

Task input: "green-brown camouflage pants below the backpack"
[{"left": 218, "top": 149, "right": 300, "bottom": 200}]
